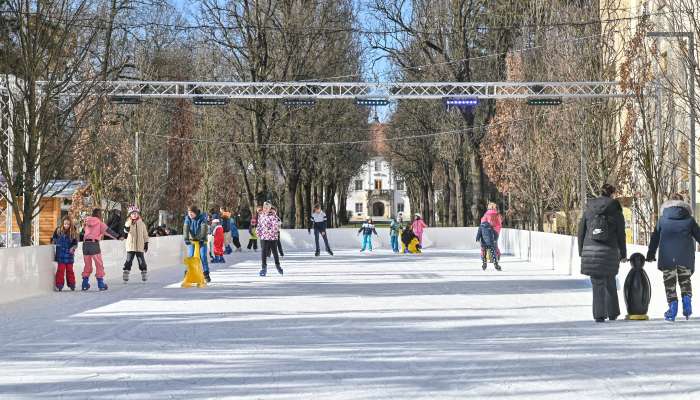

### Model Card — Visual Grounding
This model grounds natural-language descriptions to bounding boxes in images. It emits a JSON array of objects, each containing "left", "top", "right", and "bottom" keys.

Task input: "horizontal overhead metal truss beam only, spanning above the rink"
[{"left": 86, "top": 81, "right": 631, "bottom": 100}]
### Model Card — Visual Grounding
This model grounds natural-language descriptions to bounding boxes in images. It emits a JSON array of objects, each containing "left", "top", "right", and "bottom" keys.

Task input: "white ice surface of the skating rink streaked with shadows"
[{"left": 0, "top": 250, "right": 700, "bottom": 399}]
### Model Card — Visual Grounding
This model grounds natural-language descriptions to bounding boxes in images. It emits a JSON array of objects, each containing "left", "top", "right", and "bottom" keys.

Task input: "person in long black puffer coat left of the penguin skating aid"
[{"left": 578, "top": 184, "right": 627, "bottom": 322}]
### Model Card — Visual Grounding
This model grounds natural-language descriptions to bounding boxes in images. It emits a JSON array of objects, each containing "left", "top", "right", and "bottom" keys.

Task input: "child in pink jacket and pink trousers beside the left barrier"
[{"left": 82, "top": 208, "right": 118, "bottom": 291}]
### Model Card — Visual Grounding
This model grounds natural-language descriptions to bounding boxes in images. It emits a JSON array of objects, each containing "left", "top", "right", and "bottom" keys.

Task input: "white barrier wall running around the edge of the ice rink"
[{"left": 0, "top": 227, "right": 688, "bottom": 312}]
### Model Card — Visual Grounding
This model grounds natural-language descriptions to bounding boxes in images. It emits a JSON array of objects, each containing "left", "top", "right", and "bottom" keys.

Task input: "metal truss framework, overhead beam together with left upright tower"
[{"left": 0, "top": 81, "right": 632, "bottom": 245}]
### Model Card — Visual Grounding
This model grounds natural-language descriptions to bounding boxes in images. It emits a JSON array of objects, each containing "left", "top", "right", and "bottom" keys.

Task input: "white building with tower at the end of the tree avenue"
[{"left": 346, "top": 124, "right": 411, "bottom": 222}]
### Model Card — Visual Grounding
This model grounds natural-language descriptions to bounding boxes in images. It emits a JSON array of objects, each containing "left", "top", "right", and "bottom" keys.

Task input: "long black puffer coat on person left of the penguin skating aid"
[{"left": 578, "top": 196, "right": 627, "bottom": 276}]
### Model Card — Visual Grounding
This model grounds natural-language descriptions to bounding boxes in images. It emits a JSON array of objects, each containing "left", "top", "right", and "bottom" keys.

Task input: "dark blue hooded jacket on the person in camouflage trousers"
[{"left": 647, "top": 200, "right": 700, "bottom": 272}]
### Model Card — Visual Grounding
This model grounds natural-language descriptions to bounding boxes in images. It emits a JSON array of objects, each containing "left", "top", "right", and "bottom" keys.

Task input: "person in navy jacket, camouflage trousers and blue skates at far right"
[{"left": 647, "top": 194, "right": 700, "bottom": 322}]
